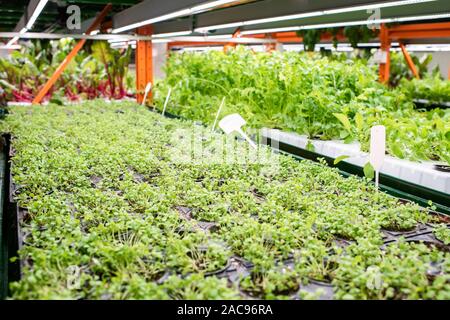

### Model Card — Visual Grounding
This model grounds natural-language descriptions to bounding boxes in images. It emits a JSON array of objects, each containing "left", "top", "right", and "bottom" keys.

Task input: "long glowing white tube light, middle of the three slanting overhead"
[{"left": 195, "top": 0, "right": 436, "bottom": 33}]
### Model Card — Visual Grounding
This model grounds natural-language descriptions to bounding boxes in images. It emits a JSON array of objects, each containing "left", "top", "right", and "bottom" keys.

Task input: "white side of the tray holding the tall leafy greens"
[{"left": 261, "top": 128, "right": 450, "bottom": 195}]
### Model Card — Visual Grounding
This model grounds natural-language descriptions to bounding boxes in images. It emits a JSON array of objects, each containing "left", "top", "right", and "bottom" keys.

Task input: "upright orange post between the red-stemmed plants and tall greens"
[{"left": 136, "top": 26, "right": 153, "bottom": 103}]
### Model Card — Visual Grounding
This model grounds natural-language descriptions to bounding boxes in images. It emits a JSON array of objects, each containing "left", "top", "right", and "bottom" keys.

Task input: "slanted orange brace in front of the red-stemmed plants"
[{"left": 33, "top": 4, "right": 112, "bottom": 104}]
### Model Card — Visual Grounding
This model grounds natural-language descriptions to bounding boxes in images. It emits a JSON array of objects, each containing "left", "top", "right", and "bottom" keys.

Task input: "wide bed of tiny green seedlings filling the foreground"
[{"left": 0, "top": 100, "right": 450, "bottom": 300}]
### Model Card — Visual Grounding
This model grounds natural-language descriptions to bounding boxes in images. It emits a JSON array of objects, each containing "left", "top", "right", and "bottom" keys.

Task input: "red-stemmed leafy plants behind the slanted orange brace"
[{"left": 0, "top": 39, "right": 132, "bottom": 103}]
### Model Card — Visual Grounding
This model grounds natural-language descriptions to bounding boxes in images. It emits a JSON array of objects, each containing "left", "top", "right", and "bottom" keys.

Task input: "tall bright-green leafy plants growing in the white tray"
[{"left": 154, "top": 47, "right": 450, "bottom": 163}]
